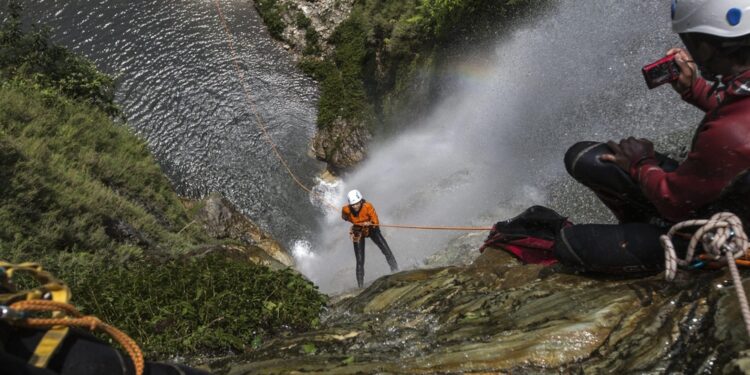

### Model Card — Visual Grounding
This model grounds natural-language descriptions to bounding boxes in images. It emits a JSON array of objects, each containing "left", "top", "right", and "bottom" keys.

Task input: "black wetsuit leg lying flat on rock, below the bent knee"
[{"left": 554, "top": 223, "right": 668, "bottom": 275}]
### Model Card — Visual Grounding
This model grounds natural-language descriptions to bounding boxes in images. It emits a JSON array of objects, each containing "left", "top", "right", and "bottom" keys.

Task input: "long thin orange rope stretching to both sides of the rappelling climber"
[{"left": 214, "top": 0, "right": 492, "bottom": 231}]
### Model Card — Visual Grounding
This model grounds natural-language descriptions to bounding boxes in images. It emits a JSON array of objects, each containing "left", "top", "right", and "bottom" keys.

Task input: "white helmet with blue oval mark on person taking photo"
[{"left": 672, "top": 0, "right": 750, "bottom": 38}]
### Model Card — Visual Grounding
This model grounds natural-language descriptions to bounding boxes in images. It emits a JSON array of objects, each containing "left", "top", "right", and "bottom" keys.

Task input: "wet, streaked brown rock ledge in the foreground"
[{"left": 211, "top": 249, "right": 750, "bottom": 375}]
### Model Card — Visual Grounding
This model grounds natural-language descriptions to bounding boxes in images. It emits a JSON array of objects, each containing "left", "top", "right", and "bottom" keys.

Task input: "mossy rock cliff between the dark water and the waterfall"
[{"left": 255, "top": 0, "right": 547, "bottom": 171}]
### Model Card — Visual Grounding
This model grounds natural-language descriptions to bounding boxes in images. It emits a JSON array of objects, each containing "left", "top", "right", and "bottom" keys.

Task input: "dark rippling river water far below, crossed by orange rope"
[{"left": 16, "top": 0, "right": 324, "bottom": 247}]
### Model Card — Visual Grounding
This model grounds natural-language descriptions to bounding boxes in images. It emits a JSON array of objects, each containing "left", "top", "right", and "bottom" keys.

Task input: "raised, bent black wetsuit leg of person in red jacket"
[{"left": 565, "top": 142, "right": 678, "bottom": 223}]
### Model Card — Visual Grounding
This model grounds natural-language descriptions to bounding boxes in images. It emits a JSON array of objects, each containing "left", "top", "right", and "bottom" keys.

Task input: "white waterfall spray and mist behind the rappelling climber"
[{"left": 295, "top": 0, "right": 702, "bottom": 293}]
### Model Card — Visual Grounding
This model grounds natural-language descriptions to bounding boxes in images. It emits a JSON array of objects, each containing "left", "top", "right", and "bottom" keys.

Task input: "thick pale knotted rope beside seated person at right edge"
[{"left": 660, "top": 212, "right": 750, "bottom": 335}]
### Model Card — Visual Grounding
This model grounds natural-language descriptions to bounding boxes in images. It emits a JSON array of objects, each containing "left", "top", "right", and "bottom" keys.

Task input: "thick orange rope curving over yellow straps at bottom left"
[{"left": 10, "top": 300, "right": 145, "bottom": 375}]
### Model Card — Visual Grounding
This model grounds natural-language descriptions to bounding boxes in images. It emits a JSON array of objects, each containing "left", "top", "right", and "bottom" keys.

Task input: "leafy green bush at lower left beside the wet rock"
[{"left": 45, "top": 253, "right": 326, "bottom": 357}]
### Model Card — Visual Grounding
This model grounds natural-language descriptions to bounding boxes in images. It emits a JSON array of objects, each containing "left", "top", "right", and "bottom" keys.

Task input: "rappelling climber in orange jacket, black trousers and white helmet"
[{"left": 341, "top": 190, "right": 398, "bottom": 288}]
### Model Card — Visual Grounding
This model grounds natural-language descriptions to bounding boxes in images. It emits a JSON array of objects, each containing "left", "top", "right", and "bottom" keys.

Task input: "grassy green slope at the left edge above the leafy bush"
[{"left": 0, "top": 81, "right": 209, "bottom": 258}]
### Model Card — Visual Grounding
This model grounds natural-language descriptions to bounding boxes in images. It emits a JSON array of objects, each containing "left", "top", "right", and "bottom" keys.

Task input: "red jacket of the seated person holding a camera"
[{"left": 630, "top": 71, "right": 750, "bottom": 222}]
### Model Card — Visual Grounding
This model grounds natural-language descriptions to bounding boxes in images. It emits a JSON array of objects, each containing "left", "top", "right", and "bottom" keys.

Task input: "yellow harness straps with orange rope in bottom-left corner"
[{"left": 0, "top": 261, "right": 145, "bottom": 375}]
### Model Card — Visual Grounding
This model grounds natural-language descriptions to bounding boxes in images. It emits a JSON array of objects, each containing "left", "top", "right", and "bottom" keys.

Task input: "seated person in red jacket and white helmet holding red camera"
[{"left": 488, "top": 0, "right": 750, "bottom": 273}]
